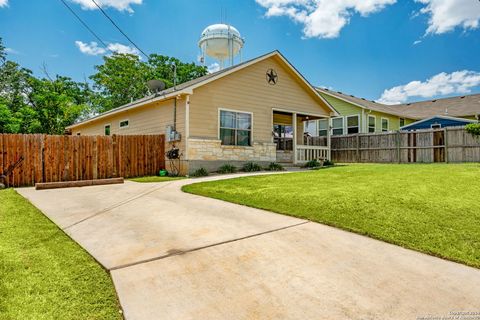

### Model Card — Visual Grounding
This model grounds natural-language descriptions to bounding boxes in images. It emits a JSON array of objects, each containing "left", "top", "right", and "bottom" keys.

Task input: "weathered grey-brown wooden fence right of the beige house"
[{"left": 324, "top": 127, "right": 480, "bottom": 163}]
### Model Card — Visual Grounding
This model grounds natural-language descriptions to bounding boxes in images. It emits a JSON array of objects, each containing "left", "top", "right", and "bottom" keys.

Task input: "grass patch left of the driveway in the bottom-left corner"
[{"left": 0, "top": 189, "right": 122, "bottom": 320}]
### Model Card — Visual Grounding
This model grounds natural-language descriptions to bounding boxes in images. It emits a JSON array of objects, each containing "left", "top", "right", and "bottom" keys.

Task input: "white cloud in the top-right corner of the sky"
[{"left": 415, "top": 0, "right": 480, "bottom": 34}]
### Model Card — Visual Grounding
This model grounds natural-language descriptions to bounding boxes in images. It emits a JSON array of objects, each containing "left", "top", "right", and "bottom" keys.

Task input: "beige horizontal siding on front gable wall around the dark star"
[{"left": 190, "top": 57, "right": 330, "bottom": 142}]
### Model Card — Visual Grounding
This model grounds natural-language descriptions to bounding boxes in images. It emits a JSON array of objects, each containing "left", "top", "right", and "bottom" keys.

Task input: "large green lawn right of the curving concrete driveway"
[{"left": 183, "top": 164, "right": 480, "bottom": 268}]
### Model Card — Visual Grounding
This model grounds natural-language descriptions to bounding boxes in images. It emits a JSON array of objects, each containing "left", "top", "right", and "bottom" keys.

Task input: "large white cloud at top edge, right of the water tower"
[{"left": 256, "top": 0, "right": 396, "bottom": 38}]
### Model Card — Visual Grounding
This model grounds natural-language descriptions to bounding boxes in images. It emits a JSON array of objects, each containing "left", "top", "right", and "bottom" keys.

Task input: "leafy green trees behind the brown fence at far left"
[{"left": 0, "top": 39, "right": 94, "bottom": 134}]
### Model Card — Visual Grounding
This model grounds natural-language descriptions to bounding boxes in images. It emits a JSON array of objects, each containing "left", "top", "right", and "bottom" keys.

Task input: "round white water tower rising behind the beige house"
[{"left": 198, "top": 23, "right": 245, "bottom": 69}]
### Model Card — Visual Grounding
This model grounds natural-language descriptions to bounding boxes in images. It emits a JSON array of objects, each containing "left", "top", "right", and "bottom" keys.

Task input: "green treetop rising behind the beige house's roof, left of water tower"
[{"left": 90, "top": 54, "right": 207, "bottom": 111}]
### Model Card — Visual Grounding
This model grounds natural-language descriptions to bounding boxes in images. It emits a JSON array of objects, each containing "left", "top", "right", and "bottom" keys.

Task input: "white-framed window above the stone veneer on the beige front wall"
[{"left": 220, "top": 110, "right": 252, "bottom": 146}]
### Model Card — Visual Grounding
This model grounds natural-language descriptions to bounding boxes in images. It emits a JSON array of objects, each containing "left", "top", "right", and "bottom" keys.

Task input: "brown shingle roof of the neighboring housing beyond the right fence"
[{"left": 317, "top": 88, "right": 480, "bottom": 120}]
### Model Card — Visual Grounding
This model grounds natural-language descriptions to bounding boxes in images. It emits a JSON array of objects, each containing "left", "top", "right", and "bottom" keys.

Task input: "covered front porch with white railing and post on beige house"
[{"left": 272, "top": 109, "right": 330, "bottom": 165}]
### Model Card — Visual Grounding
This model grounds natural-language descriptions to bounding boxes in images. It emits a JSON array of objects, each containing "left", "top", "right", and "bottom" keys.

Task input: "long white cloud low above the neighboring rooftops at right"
[{"left": 378, "top": 70, "right": 480, "bottom": 104}]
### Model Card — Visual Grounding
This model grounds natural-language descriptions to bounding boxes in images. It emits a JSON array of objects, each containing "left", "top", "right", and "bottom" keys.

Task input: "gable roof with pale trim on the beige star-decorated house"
[{"left": 66, "top": 50, "right": 338, "bottom": 129}]
